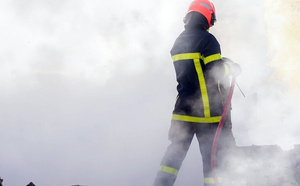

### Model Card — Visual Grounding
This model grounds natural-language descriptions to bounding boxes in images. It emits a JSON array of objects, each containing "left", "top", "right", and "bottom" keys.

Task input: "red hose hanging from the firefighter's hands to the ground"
[{"left": 211, "top": 76, "right": 235, "bottom": 186}]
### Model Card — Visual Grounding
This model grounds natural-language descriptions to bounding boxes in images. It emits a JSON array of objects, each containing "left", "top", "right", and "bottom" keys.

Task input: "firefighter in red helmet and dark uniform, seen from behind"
[{"left": 154, "top": 0, "right": 241, "bottom": 186}]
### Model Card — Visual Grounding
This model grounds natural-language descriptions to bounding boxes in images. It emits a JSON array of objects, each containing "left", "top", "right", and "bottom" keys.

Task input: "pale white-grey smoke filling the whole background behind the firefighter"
[{"left": 0, "top": 0, "right": 300, "bottom": 186}]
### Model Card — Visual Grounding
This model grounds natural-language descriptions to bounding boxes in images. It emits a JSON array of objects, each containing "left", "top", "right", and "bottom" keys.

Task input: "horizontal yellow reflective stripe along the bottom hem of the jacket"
[{"left": 172, "top": 114, "right": 221, "bottom": 123}]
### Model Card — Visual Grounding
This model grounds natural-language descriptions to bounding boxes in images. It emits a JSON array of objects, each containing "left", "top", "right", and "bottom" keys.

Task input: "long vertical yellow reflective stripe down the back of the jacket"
[{"left": 194, "top": 59, "right": 210, "bottom": 118}]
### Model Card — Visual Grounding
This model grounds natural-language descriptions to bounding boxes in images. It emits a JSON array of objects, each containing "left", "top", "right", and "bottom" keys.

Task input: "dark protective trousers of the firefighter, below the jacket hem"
[{"left": 153, "top": 116, "right": 235, "bottom": 186}]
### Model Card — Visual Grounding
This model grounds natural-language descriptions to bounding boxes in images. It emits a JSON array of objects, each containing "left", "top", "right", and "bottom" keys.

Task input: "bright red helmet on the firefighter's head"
[{"left": 185, "top": 0, "right": 216, "bottom": 27}]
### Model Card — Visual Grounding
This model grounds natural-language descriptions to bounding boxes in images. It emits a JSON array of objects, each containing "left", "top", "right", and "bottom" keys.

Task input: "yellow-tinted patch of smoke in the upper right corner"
[{"left": 265, "top": 0, "right": 300, "bottom": 96}]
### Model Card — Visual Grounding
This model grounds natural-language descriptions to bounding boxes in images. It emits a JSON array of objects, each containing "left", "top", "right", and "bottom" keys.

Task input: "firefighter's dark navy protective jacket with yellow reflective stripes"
[{"left": 171, "top": 12, "right": 231, "bottom": 123}]
